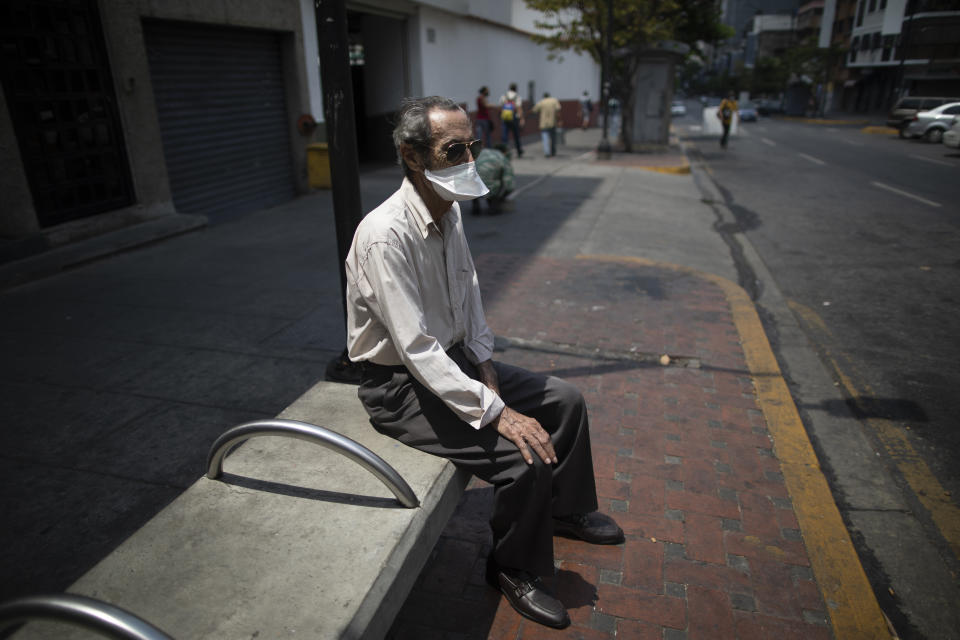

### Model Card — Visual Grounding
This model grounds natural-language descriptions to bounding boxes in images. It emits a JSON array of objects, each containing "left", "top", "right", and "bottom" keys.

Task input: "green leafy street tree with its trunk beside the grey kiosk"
[{"left": 526, "top": 0, "right": 728, "bottom": 151}]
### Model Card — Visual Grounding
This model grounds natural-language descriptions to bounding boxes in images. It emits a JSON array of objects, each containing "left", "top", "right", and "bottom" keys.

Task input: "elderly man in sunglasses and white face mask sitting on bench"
[{"left": 346, "top": 96, "right": 624, "bottom": 628}]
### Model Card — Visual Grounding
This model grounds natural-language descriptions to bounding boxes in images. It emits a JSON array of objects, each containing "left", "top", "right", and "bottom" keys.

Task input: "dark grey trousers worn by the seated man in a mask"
[{"left": 358, "top": 347, "right": 597, "bottom": 576}]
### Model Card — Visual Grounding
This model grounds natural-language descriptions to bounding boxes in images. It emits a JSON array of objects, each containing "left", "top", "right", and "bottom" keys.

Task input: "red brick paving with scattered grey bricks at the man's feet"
[{"left": 390, "top": 255, "right": 832, "bottom": 640}]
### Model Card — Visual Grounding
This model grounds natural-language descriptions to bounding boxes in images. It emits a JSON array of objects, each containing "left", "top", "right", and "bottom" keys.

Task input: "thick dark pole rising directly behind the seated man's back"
[{"left": 314, "top": 0, "right": 363, "bottom": 382}]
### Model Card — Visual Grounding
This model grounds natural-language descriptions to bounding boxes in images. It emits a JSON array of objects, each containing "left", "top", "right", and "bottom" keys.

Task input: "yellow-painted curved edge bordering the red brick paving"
[{"left": 577, "top": 255, "right": 891, "bottom": 640}]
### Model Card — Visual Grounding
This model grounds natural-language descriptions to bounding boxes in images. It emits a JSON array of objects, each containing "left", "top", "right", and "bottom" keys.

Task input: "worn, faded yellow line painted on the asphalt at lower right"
[{"left": 788, "top": 300, "right": 960, "bottom": 558}]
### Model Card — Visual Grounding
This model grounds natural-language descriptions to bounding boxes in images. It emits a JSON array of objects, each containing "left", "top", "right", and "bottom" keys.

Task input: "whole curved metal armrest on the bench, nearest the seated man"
[{"left": 207, "top": 419, "right": 420, "bottom": 509}]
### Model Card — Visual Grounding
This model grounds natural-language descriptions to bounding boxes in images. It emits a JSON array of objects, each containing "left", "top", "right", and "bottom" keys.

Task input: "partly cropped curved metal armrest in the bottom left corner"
[{"left": 0, "top": 593, "right": 173, "bottom": 640}]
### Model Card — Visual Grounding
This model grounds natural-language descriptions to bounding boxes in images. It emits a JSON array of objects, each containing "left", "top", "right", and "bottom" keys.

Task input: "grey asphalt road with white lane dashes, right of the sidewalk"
[{"left": 675, "top": 102, "right": 960, "bottom": 638}]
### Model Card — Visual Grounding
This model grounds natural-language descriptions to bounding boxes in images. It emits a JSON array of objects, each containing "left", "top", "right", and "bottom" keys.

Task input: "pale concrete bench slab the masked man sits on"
[{"left": 14, "top": 382, "right": 469, "bottom": 640}]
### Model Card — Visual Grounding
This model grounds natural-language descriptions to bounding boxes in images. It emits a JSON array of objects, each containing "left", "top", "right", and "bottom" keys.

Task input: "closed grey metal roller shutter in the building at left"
[{"left": 144, "top": 21, "right": 295, "bottom": 218}]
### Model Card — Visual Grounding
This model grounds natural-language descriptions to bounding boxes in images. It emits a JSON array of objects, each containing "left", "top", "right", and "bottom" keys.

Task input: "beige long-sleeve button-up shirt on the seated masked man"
[{"left": 346, "top": 179, "right": 504, "bottom": 429}]
